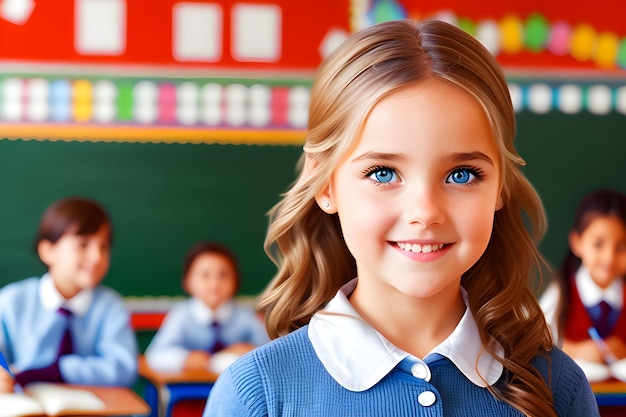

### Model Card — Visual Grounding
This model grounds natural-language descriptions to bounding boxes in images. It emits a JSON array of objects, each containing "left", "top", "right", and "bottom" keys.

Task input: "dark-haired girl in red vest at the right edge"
[{"left": 541, "top": 190, "right": 626, "bottom": 380}]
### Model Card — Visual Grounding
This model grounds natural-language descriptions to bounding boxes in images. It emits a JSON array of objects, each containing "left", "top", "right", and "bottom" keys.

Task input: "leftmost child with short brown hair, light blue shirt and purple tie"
[{"left": 0, "top": 198, "right": 137, "bottom": 392}]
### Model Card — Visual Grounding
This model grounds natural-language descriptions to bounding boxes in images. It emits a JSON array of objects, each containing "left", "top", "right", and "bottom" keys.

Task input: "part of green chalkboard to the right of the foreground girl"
[{"left": 516, "top": 111, "right": 626, "bottom": 267}]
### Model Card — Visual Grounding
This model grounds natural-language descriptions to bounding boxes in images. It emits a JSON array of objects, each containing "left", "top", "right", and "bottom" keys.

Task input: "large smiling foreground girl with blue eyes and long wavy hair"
[{"left": 204, "top": 17, "right": 598, "bottom": 417}]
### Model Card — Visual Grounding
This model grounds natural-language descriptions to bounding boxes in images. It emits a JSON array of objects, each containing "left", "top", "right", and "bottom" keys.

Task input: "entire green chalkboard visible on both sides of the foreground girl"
[{"left": 0, "top": 111, "right": 626, "bottom": 296}]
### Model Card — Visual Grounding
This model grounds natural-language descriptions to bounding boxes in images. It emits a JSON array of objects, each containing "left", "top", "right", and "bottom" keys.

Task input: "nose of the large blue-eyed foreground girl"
[{"left": 403, "top": 186, "right": 445, "bottom": 227}]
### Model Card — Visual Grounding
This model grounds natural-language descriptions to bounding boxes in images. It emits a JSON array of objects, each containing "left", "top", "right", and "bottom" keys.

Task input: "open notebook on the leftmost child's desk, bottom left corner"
[{"left": 0, "top": 383, "right": 106, "bottom": 417}]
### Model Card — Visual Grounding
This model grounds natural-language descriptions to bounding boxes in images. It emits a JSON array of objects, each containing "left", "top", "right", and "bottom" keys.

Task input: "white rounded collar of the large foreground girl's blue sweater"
[{"left": 308, "top": 278, "right": 503, "bottom": 391}]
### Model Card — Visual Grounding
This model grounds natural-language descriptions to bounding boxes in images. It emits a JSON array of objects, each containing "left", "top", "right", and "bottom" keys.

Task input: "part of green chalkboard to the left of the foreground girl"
[{"left": 0, "top": 140, "right": 301, "bottom": 296}]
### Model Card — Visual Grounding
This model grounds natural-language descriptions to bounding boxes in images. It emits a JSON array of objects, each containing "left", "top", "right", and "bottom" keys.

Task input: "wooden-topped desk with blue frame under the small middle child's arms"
[{"left": 139, "top": 355, "right": 218, "bottom": 417}]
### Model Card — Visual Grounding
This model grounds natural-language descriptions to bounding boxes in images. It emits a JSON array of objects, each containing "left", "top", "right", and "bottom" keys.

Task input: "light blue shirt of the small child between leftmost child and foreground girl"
[{"left": 145, "top": 298, "right": 269, "bottom": 372}]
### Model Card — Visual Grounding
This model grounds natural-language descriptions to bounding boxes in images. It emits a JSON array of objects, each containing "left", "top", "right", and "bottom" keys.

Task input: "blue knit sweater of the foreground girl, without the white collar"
[{"left": 203, "top": 326, "right": 599, "bottom": 417}]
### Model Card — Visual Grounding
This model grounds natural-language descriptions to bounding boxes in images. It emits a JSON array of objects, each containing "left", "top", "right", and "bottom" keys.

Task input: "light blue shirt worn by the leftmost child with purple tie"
[{"left": 0, "top": 274, "right": 138, "bottom": 386}]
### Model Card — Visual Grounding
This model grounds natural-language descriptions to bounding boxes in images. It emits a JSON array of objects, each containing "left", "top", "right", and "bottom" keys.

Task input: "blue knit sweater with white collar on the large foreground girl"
[{"left": 204, "top": 280, "right": 599, "bottom": 417}]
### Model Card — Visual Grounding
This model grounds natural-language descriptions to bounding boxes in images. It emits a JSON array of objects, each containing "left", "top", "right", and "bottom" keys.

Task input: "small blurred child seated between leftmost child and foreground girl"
[{"left": 146, "top": 242, "right": 269, "bottom": 373}]
